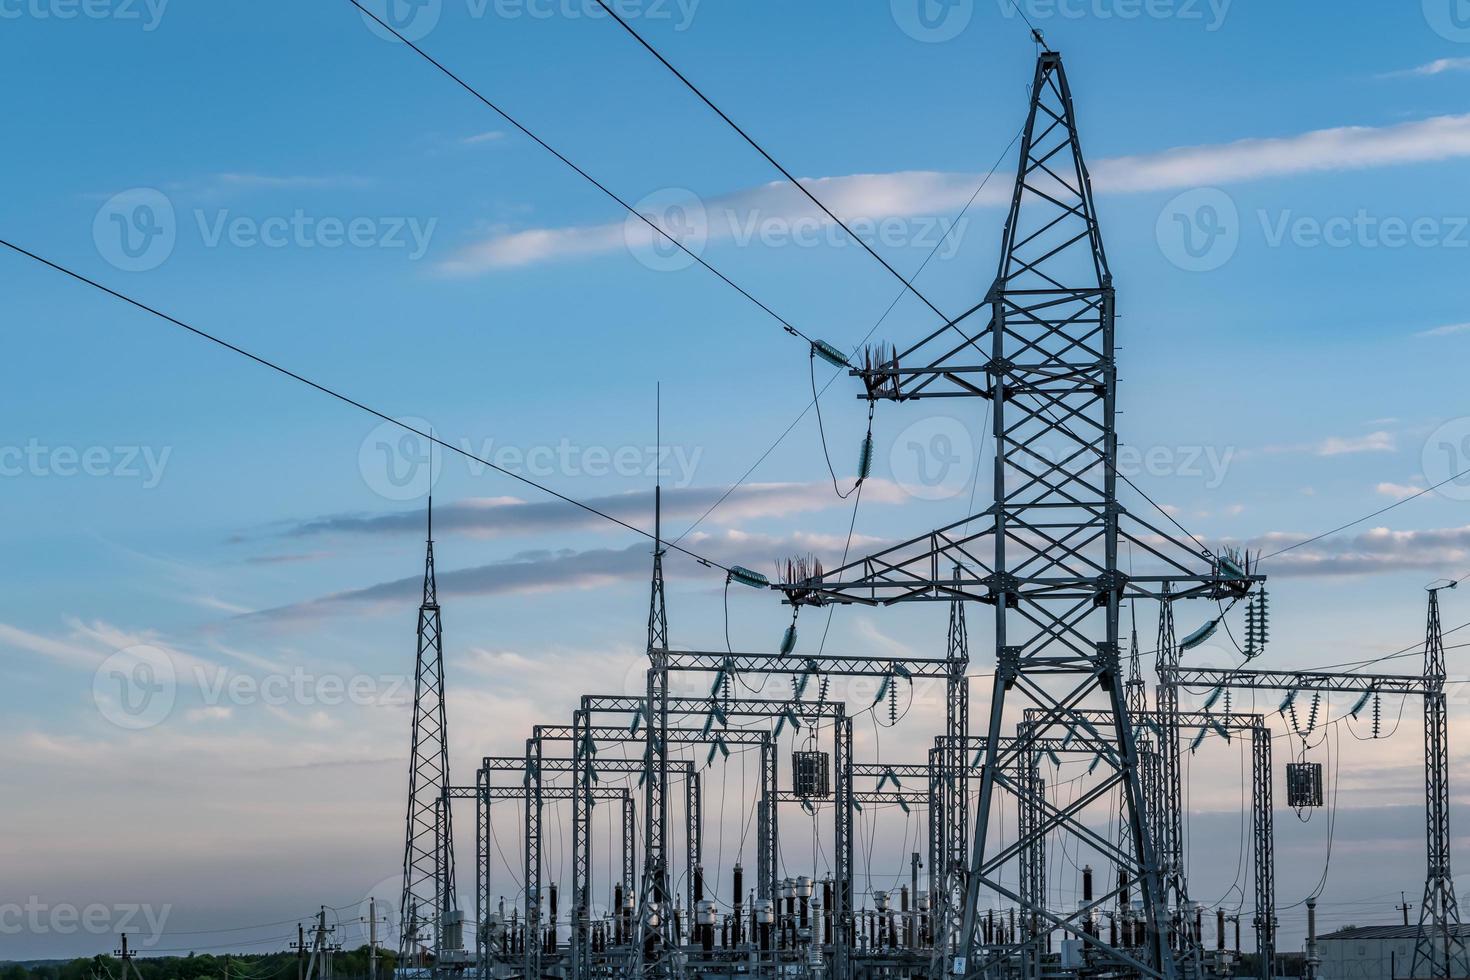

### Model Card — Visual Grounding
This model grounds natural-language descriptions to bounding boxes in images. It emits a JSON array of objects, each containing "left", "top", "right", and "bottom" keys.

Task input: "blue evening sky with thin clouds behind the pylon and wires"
[{"left": 0, "top": 0, "right": 1470, "bottom": 955}]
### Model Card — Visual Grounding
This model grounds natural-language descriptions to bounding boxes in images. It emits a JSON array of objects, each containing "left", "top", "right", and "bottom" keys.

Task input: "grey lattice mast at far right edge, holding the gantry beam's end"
[{"left": 1408, "top": 583, "right": 1470, "bottom": 980}]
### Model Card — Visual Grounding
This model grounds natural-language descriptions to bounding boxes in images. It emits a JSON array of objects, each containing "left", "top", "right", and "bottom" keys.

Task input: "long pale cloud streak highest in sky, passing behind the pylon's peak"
[{"left": 440, "top": 115, "right": 1470, "bottom": 276}]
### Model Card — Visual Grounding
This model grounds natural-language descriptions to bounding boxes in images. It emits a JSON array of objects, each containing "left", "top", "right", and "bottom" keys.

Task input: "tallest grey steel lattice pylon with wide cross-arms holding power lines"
[{"left": 782, "top": 50, "right": 1258, "bottom": 977}]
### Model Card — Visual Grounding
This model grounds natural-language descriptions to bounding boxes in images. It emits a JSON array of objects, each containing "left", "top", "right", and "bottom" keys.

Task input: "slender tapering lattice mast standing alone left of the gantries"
[{"left": 398, "top": 498, "right": 457, "bottom": 967}]
